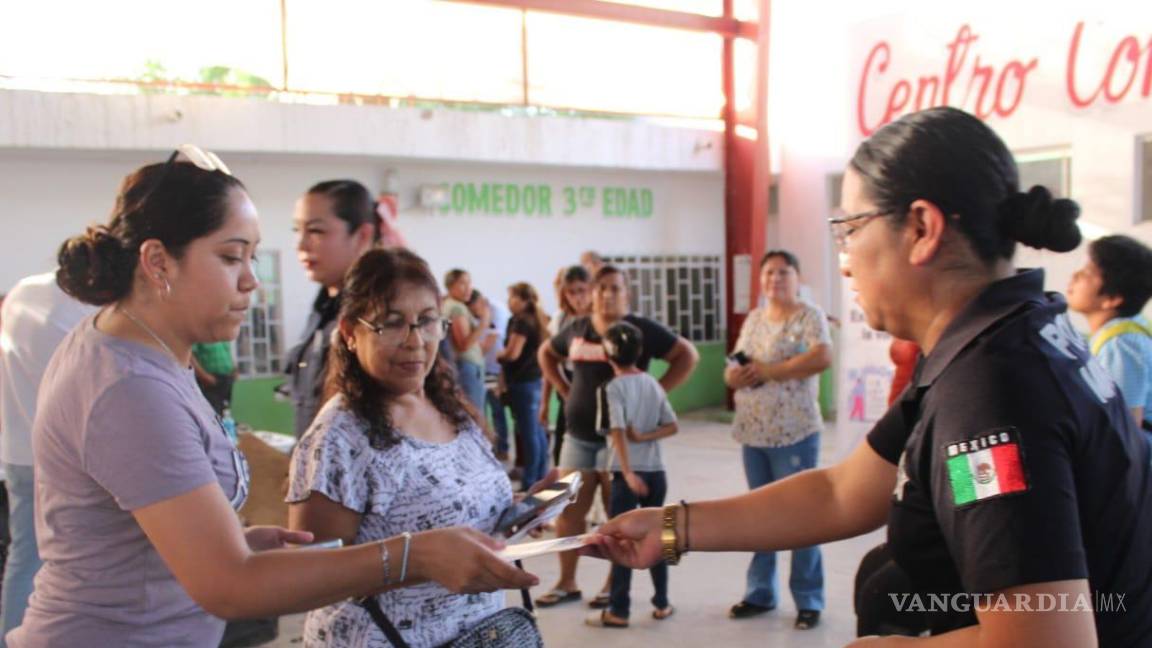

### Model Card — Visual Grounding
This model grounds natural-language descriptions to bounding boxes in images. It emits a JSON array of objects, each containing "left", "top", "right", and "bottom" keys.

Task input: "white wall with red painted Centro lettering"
[{"left": 770, "top": 0, "right": 1152, "bottom": 311}]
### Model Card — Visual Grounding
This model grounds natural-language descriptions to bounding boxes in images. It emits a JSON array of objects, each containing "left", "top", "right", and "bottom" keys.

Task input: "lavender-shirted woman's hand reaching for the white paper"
[{"left": 409, "top": 527, "right": 540, "bottom": 594}]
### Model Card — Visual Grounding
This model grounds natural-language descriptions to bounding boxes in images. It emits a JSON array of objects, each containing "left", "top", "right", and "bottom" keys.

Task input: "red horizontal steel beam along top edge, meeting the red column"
[{"left": 445, "top": 0, "right": 759, "bottom": 39}]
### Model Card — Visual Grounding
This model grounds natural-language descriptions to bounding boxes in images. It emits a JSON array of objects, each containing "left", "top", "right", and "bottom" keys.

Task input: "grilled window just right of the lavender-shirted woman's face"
[{"left": 236, "top": 250, "right": 285, "bottom": 378}]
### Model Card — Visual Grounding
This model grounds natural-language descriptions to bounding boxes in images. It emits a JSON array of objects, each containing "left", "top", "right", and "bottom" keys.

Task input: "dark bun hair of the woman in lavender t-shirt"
[{"left": 56, "top": 161, "right": 244, "bottom": 306}]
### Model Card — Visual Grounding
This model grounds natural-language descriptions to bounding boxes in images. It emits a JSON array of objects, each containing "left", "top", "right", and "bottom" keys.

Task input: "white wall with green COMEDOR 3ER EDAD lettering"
[{"left": 0, "top": 91, "right": 723, "bottom": 340}]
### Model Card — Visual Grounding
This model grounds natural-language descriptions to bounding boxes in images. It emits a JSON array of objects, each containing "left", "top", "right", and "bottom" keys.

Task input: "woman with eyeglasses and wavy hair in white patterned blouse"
[{"left": 288, "top": 250, "right": 543, "bottom": 647}]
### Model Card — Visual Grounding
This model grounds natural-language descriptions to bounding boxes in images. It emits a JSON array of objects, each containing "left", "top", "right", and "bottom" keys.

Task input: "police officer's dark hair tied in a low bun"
[{"left": 850, "top": 106, "right": 1081, "bottom": 264}]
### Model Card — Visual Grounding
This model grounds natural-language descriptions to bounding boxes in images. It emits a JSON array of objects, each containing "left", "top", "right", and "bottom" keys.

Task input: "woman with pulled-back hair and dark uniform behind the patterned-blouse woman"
[{"left": 285, "top": 180, "right": 381, "bottom": 438}]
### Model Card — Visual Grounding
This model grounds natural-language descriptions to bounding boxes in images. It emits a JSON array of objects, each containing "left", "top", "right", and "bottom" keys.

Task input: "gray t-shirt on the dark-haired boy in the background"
[{"left": 604, "top": 374, "right": 676, "bottom": 472}]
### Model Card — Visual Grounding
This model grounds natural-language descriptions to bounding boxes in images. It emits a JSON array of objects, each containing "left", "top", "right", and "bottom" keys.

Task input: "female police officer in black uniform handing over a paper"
[{"left": 597, "top": 107, "right": 1152, "bottom": 648}]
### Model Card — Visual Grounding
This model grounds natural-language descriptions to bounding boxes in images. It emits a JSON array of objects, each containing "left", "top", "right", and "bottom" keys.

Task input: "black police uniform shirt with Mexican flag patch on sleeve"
[{"left": 867, "top": 270, "right": 1152, "bottom": 647}]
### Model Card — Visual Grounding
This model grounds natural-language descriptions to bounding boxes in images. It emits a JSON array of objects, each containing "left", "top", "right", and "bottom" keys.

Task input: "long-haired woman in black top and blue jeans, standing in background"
[{"left": 497, "top": 281, "right": 548, "bottom": 485}]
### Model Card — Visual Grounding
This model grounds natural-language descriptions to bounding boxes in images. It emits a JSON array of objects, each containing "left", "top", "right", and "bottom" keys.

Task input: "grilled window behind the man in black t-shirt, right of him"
[{"left": 606, "top": 255, "right": 727, "bottom": 342}]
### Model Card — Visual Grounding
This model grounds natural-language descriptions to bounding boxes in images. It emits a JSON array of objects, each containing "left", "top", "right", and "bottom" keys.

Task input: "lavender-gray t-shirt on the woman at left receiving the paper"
[{"left": 7, "top": 317, "right": 248, "bottom": 648}]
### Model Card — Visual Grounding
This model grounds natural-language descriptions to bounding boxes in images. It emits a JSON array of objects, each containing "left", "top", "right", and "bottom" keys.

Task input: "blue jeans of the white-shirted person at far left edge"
[{"left": 0, "top": 464, "right": 40, "bottom": 647}]
